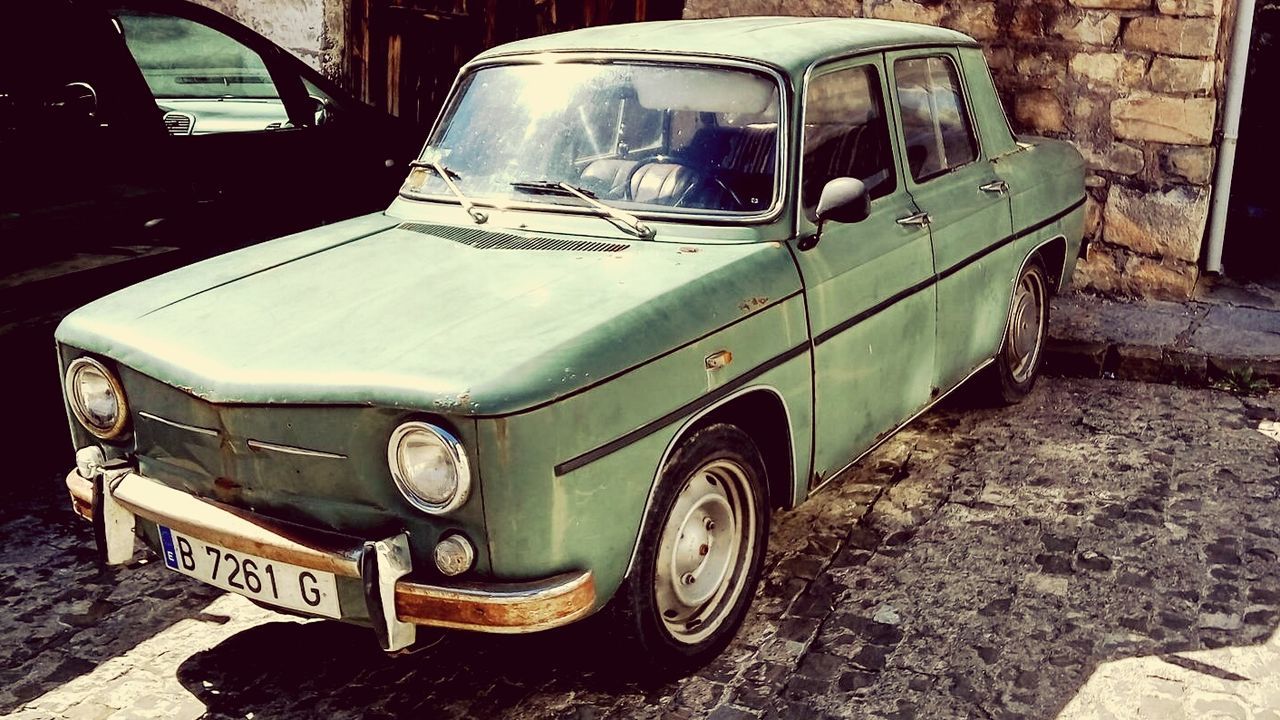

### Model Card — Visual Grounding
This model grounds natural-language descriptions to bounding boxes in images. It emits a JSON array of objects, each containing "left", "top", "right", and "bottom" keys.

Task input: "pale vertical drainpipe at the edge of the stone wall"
[{"left": 1204, "top": 0, "right": 1254, "bottom": 273}]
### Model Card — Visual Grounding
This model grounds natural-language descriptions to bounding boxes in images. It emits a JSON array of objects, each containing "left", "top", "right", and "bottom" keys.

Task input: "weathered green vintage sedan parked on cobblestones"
[{"left": 58, "top": 18, "right": 1084, "bottom": 669}]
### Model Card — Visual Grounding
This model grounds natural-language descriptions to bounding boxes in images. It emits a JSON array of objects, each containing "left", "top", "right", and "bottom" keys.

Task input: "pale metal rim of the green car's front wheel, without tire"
[{"left": 654, "top": 460, "right": 758, "bottom": 644}]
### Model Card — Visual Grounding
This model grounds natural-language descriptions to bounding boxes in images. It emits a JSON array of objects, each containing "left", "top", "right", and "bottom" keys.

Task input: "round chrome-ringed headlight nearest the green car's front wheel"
[{"left": 387, "top": 421, "right": 471, "bottom": 514}]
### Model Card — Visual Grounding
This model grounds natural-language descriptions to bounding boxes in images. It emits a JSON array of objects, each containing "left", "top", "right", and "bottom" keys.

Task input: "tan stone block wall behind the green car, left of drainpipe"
[{"left": 685, "top": 0, "right": 1230, "bottom": 299}]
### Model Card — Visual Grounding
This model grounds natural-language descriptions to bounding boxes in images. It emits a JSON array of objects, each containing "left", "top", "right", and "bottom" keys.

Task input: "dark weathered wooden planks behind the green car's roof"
[{"left": 347, "top": 0, "right": 685, "bottom": 128}]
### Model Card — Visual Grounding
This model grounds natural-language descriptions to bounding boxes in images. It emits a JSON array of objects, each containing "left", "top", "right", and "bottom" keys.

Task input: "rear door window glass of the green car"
[{"left": 893, "top": 56, "right": 978, "bottom": 182}]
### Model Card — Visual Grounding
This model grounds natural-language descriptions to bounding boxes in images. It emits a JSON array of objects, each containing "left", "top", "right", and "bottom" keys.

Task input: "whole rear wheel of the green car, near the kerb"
[{"left": 984, "top": 256, "right": 1050, "bottom": 405}]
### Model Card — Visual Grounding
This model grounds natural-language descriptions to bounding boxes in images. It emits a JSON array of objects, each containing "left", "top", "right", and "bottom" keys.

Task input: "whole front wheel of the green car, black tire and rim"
[{"left": 607, "top": 424, "right": 769, "bottom": 676}]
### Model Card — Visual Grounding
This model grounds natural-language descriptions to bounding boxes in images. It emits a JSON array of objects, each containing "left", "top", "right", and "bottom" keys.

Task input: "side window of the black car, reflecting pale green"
[{"left": 115, "top": 10, "right": 289, "bottom": 135}]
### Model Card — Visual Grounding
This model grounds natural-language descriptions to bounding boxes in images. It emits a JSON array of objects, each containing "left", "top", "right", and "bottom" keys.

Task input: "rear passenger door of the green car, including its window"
[{"left": 886, "top": 49, "right": 1012, "bottom": 393}]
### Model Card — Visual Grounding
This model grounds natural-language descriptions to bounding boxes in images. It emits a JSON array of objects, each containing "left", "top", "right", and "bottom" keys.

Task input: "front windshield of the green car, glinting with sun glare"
[{"left": 402, "top": 61, "right": 780, "bottom": 215}]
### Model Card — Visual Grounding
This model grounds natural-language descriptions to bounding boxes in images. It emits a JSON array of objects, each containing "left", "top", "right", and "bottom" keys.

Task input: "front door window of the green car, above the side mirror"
[{"left": 800, "top": 65, "right": 897, "bottom": 219}]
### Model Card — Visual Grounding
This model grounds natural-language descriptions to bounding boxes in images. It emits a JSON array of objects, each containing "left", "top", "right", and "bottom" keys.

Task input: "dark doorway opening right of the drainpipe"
[{"left": 1222, "top": 0, "right": 1280, "bottom": 284}]
